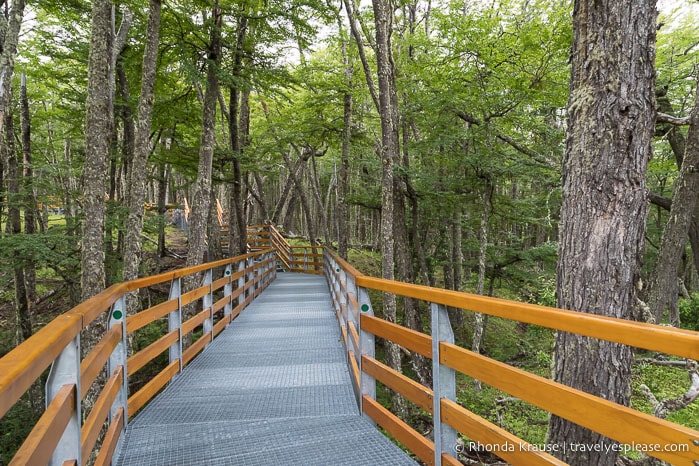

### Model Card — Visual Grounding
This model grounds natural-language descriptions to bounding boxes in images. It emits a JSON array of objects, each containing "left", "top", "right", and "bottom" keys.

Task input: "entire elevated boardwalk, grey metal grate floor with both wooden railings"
[{"left": 0, "top": 229, "right": 699, "bottom": 466}]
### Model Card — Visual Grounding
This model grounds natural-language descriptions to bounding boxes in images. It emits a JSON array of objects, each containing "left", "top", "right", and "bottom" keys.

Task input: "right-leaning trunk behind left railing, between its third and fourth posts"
[{"left": 186, "top": 1, "right": 222, "bottom": 272}]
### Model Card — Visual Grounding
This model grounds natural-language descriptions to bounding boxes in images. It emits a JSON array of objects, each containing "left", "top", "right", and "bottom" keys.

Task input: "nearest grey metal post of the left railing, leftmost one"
[{"left": 46, "top": 333, "right": 82, "bottom": 466}]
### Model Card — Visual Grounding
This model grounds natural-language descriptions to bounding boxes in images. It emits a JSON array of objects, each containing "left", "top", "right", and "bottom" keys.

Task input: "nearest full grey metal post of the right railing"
[{"left": 432, "top": 303, "right": 456, "bottom": 465}]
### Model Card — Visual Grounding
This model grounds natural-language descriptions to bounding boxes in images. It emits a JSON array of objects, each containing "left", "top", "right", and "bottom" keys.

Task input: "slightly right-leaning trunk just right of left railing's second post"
[{"left": 124, "top": 0, "right": 161, "bottom": 292}]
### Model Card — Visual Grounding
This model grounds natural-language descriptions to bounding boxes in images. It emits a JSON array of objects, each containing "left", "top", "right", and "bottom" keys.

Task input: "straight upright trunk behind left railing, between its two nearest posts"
[{"left": 80, "top": 0, "right": 112, "bottom": 300}]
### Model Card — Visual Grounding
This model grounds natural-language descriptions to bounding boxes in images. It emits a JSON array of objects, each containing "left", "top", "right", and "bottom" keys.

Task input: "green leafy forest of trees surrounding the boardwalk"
[{"left": 0, "top": 0, "right": 699, "bottom": 465}]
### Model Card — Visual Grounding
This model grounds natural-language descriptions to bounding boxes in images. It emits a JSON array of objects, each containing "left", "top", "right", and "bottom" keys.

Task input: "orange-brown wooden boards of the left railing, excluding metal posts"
[{"left": 0, "top": 248, "right": 275, "bottom": 464}]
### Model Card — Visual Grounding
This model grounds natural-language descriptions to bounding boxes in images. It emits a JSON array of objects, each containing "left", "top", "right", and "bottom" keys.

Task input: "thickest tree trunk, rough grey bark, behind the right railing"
[{"left": 548, "top": 0, "right": 657, "bottom": 466}]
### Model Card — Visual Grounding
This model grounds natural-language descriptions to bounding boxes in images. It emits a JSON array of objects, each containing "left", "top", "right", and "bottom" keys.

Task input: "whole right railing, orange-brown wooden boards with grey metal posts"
[{"left": 325, "top": 249, "right": 699, "bottom": 465}]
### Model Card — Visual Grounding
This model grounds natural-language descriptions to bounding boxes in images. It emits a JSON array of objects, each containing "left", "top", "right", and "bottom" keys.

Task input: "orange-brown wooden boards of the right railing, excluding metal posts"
[{"left": 325, "top": 248, "right": 699, "bottom": 464}]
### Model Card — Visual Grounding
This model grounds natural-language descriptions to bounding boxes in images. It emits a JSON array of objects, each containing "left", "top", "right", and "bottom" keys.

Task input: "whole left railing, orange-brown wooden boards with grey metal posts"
[{"left": 0, "top": 249, "right": 276, "bottom": 466}]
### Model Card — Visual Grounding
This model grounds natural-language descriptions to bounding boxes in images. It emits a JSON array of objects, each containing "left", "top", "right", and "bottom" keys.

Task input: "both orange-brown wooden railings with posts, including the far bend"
[{"left": 5, "top": 227, "right": 699, "bottom": 466}]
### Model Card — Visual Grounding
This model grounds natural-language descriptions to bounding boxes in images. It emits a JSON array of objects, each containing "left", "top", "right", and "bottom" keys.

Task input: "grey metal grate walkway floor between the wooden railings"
[{"left": 115, "top": 273, "right": 416, "bottom": 466}]
